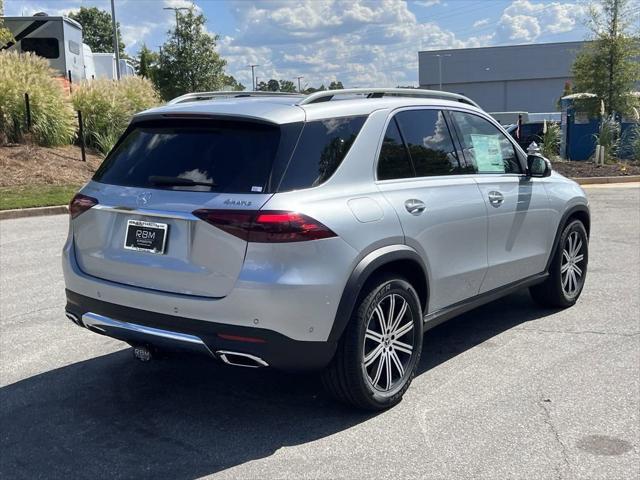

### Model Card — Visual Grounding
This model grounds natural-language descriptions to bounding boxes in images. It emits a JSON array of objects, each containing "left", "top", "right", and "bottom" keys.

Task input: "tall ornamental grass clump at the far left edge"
[{"left": 0, "top": 52, "right": 76, "bottom": 146}]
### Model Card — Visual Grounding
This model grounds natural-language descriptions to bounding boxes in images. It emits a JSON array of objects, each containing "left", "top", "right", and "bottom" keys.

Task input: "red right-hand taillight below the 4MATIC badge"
[{"left": 193, "top": 209, "right": 336, "bottom": 243}]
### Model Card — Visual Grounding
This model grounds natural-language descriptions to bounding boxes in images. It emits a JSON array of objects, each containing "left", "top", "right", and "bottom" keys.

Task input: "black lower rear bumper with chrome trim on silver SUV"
[{"left": 66, "top": 290, "right": 336, "bottom": 371}]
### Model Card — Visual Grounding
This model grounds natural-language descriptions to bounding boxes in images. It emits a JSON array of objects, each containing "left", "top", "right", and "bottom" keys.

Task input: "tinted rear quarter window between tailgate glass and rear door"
[{"left": 278, "top": 117, "right": 366, "bottom": 191}]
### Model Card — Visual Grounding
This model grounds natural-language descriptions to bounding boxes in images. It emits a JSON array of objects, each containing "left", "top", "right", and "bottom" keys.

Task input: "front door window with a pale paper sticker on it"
[{"left": 451, "top": 112, "right": 522, "bottom": 173}]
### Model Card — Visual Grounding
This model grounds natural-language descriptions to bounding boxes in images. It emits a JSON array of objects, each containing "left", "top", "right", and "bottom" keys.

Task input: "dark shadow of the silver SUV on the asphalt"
[{"left": 0, "top": 293, "right": 550, "bottom": 479}]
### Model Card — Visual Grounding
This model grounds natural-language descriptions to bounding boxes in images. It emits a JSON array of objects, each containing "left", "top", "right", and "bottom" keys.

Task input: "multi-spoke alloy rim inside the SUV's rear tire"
[{"left": 362, "top": 293, "right": 415, "bottom": 392}]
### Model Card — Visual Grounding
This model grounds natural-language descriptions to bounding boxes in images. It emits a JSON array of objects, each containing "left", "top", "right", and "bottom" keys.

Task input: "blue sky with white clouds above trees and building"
[{"left": 4, "top": 0, "right": 628, "bottom": 87}]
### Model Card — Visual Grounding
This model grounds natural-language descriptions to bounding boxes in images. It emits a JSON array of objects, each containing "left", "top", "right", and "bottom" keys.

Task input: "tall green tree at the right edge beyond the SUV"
[{"left": 573, "top": 0, "right": 640, "bottom": 114}]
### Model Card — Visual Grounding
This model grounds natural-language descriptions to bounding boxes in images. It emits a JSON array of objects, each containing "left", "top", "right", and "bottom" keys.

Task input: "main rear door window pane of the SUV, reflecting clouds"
[{"left": 396, "top": 110, "right": 466, "bottom": 177}]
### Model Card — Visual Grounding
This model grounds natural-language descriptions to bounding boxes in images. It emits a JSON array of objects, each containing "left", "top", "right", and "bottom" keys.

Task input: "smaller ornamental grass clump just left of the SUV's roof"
[{"left": 72, "top": 77, "right": 160, "bottom": 155}]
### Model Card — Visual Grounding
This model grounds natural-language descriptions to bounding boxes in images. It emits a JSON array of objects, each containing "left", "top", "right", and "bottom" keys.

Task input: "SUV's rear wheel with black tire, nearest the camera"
[{"left": 322, "top": 275, "right": 423, "bottom": 411}]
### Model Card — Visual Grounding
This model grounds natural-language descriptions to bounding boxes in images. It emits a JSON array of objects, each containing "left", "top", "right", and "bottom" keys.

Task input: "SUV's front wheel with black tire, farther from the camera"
[{"left": 529, "top": 220, "right": 589, "bottom": 308}]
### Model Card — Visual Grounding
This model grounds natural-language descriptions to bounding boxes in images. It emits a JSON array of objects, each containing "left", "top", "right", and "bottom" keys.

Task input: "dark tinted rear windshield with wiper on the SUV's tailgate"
[{"left": 93, "top": 120, "right": 302, "bottom": 193}]
